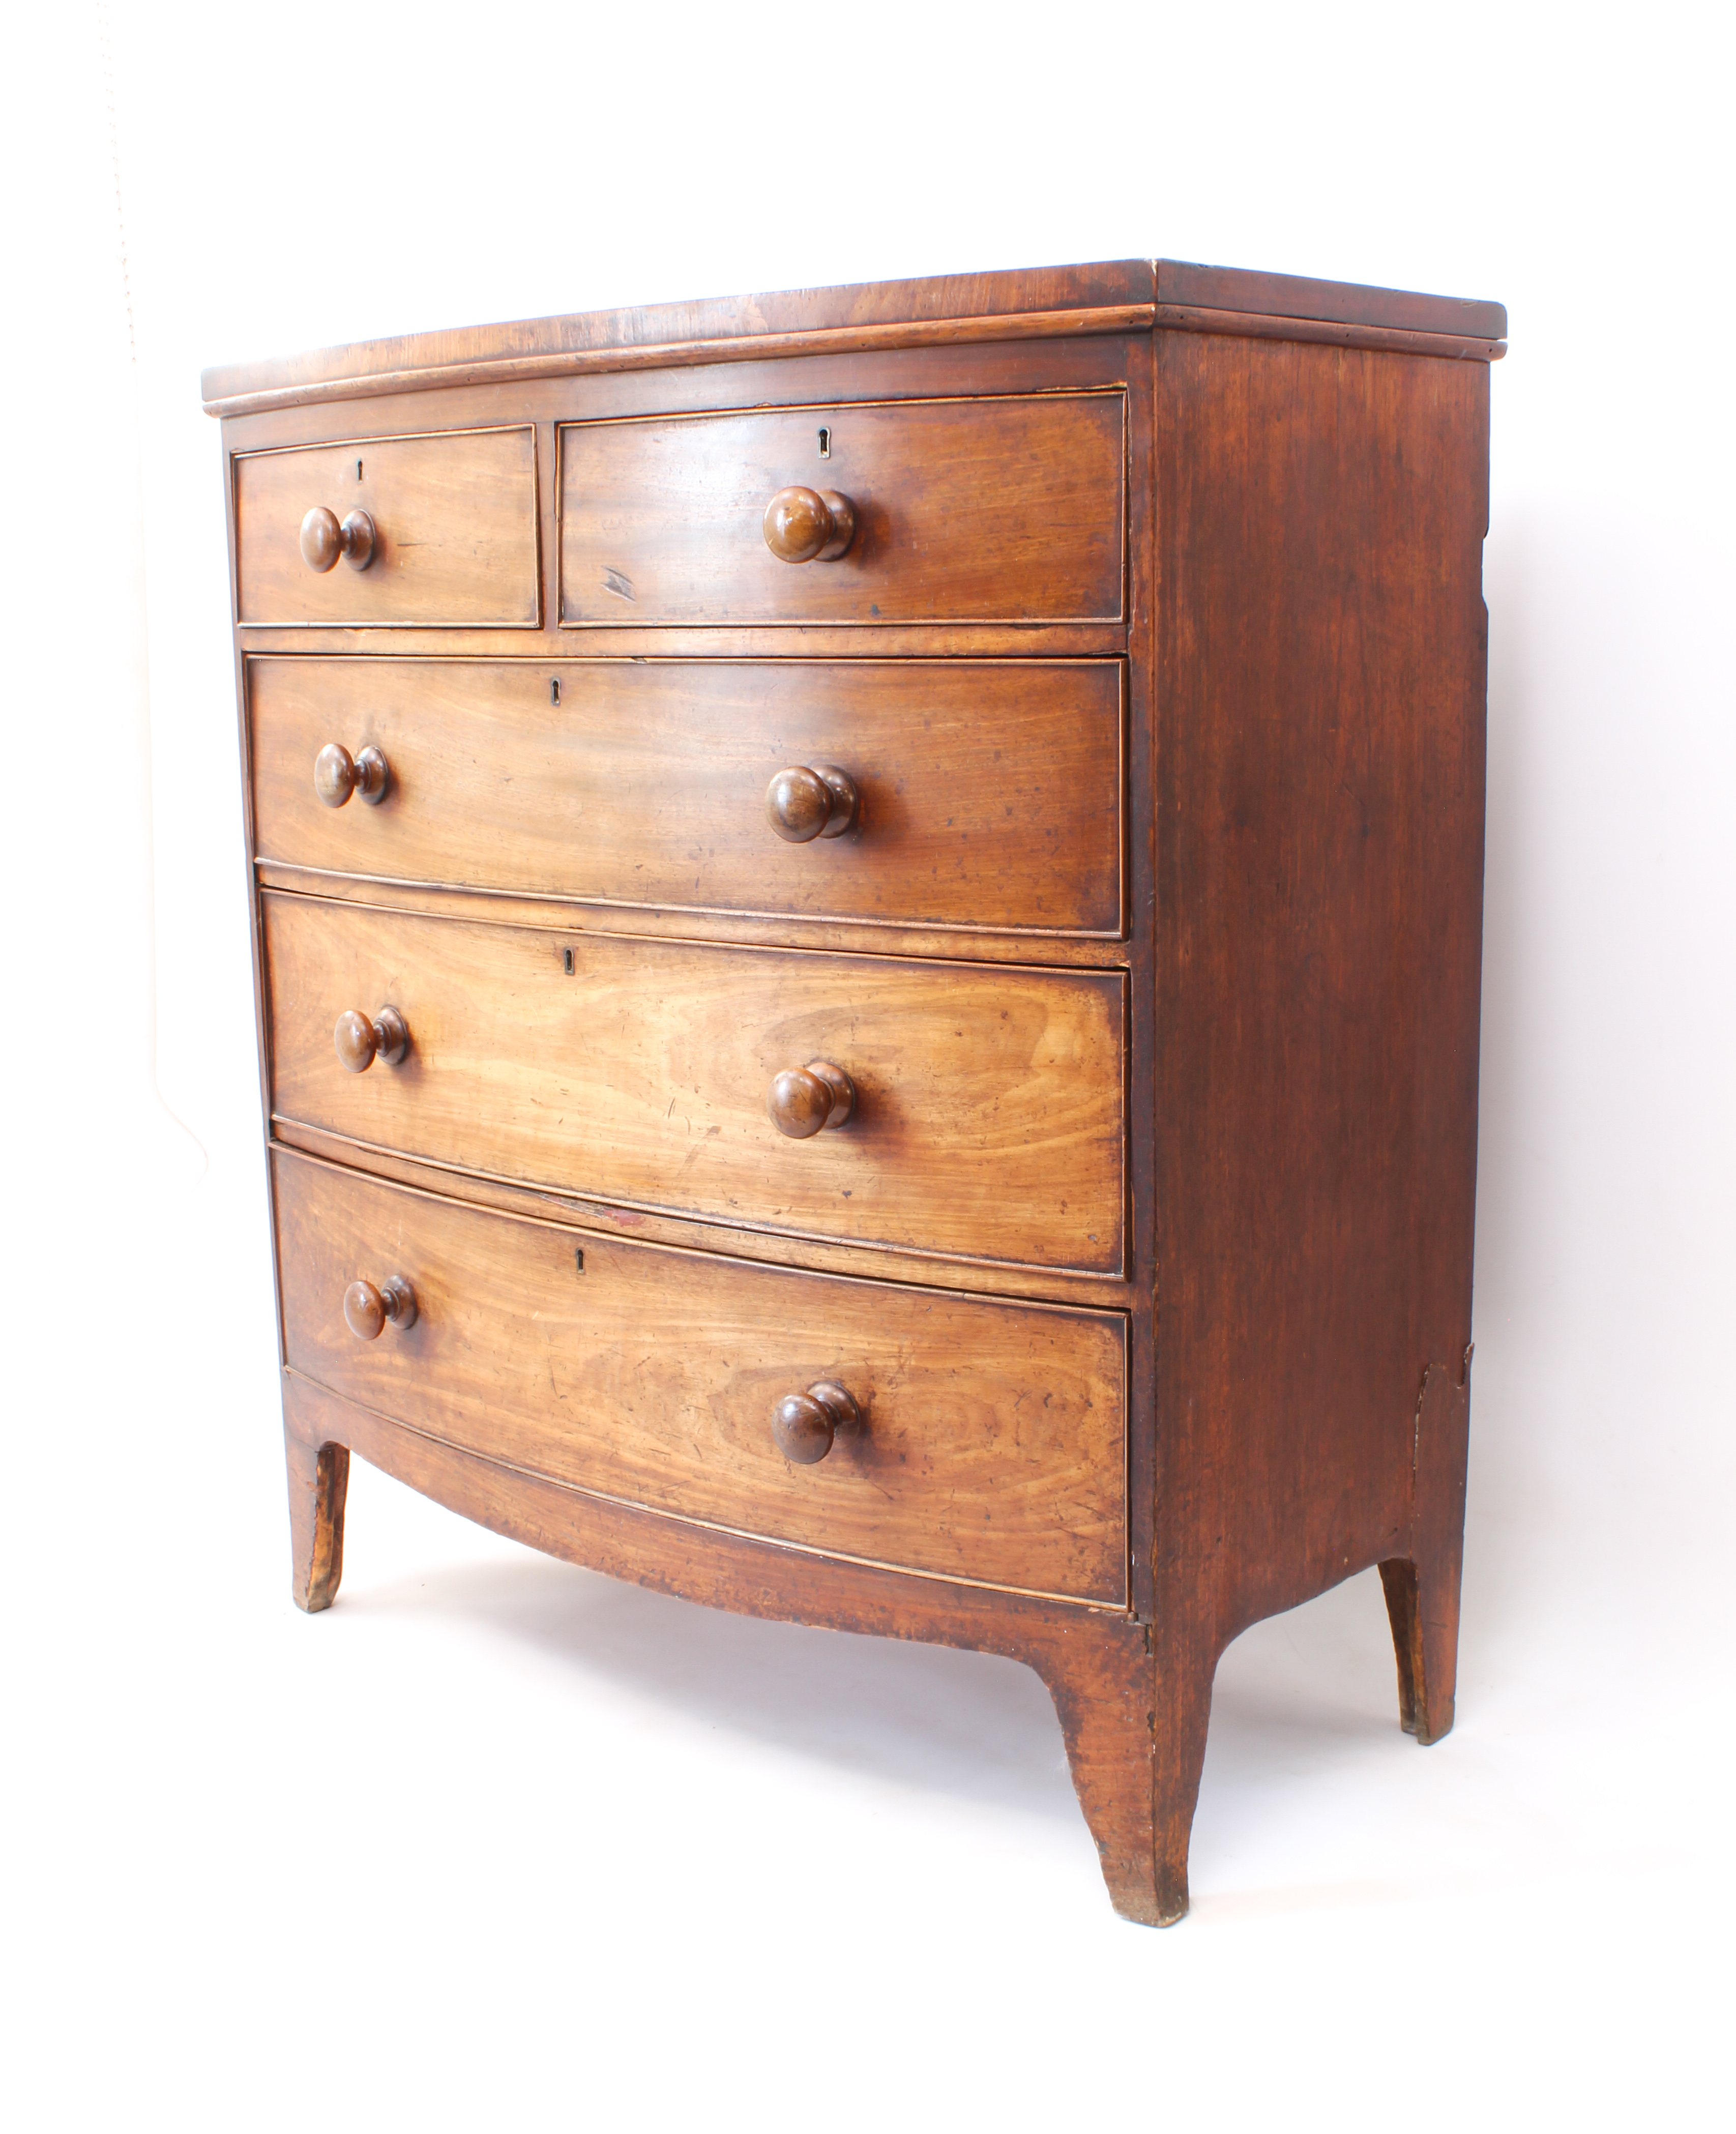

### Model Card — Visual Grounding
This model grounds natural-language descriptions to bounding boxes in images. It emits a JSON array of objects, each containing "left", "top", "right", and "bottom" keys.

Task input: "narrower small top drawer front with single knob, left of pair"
[{"left": 234, "top": 425, "right": 542, "bottom": 627}]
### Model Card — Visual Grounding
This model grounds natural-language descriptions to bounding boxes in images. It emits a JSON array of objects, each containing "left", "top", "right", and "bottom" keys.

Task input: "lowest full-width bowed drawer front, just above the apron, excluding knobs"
[{"left": 275, "top": 1152, "right": 1126, "bottom": 1605}]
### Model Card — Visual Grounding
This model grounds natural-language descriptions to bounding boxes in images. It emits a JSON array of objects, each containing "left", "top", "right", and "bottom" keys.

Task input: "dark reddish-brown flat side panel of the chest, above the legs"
[{"left": 1156, "top": 335, "right": 1489, "bottom": 1650}]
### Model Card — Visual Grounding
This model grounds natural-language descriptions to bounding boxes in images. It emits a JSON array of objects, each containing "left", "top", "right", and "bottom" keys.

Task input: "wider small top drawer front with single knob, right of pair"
[{"left": 561, "top": 391, "right": 1126, "bottom": 627}]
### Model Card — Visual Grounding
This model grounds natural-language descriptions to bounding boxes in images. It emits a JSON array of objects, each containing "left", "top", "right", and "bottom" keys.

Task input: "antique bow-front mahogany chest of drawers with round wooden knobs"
[{"left": 205, "top": 260, "right": 1506, "bottom": 1923}]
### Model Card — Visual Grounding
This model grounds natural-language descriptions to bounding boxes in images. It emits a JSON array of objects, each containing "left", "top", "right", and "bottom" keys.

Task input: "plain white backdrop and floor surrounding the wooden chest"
[{"left": 0, "top": 0, "right": 1736, "bottom": 2127}]
